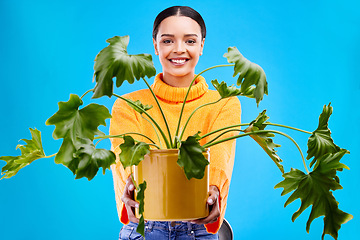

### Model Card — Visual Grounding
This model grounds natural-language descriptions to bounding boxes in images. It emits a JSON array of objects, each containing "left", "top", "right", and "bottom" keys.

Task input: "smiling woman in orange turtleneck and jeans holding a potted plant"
[{"left": 110, "top": 6, "right": 241, "bottom": 240}]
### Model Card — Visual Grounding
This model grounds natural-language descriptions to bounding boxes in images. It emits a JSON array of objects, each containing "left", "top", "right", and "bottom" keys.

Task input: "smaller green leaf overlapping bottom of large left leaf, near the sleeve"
[{"left": 74, "top": 139, "right": 116, "bottom": 181}]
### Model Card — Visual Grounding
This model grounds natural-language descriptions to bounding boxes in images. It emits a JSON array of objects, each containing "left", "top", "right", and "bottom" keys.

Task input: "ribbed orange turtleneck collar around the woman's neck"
[{"left": 151, "top": 73, "right": 209, "bottom": 103}]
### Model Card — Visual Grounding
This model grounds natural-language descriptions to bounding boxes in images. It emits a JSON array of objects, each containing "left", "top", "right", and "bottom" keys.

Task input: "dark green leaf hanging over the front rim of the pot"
[{"left": 177, "top": 133, "right": 209, "bottom": 179}]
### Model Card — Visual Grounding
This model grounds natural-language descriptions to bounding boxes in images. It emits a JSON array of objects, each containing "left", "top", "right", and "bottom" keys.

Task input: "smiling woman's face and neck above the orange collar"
[{"left": 154, "top": 16, "right": 205, "bottom": 87}]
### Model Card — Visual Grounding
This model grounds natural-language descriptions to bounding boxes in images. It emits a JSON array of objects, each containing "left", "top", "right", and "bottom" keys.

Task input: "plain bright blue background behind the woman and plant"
[{"left": 0, "top": 0, "right": 360, "bottom": 240}]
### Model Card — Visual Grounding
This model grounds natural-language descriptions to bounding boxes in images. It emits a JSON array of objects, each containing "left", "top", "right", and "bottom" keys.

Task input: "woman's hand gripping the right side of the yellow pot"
[{"left": 191, "top": 186, "right": 220, "bottom": 224}]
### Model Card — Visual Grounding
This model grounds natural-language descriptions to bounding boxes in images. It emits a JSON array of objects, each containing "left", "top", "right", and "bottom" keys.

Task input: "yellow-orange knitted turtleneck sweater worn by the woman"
[{"left": 110, "top": 73, "right": 241, "bottom": 233}]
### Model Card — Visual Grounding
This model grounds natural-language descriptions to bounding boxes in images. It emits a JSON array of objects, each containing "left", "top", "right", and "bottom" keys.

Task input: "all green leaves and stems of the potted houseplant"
[{"left": 0, "top": 36, "right": 352, "bottom": 239}]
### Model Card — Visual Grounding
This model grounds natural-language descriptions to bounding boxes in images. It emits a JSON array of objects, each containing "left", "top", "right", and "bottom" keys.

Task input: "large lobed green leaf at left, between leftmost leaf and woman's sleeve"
[{"left": 46, "top": 94, "right": 111, "bottom": 179}]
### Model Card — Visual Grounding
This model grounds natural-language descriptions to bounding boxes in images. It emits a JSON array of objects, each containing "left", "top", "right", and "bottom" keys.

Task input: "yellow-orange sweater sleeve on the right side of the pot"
[{"left": 205, "top": 97, "right": 241, "bottom": 233}]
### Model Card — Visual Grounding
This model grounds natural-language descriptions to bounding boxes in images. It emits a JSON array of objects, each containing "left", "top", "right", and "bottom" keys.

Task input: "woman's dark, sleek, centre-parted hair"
[{"left": 153, "top": 6, "right": 206, "bottom": 39}]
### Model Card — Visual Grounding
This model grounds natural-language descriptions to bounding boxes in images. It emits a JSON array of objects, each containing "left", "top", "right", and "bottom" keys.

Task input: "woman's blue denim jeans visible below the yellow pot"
[{"left": 119, "top": 221, "right": 219, "bottom": 240}]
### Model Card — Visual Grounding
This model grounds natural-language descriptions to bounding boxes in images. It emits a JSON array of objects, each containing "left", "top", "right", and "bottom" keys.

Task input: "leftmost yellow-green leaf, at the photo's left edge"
[{"left": 0, "top": 128, "right": 45, "bottom": 179}]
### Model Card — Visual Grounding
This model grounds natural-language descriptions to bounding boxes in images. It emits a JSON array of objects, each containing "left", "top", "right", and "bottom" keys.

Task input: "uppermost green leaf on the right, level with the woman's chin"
[{"left": 224, "top": 47, "right": 268, "bottom": 106}]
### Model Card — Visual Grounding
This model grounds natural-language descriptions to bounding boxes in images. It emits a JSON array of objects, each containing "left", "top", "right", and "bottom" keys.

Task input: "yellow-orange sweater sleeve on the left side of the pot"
[{"left": 110, "top": 96, "right": 139, "bottom": 224}]
